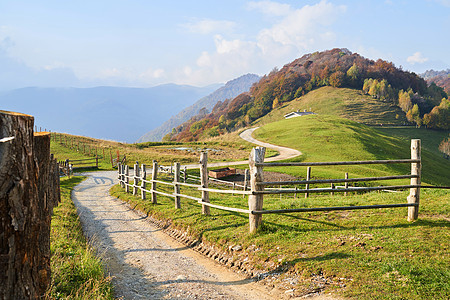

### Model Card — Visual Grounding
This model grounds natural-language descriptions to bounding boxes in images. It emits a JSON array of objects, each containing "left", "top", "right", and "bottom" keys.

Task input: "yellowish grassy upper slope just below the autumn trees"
[{"left": 255, "top": 86, "right": 406, "bottom": 125}]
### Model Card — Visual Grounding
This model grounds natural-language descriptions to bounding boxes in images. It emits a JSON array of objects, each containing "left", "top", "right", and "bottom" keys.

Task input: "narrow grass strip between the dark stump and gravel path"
[{"left": 47, "top": 177, "right": 113, "bottom": 299}]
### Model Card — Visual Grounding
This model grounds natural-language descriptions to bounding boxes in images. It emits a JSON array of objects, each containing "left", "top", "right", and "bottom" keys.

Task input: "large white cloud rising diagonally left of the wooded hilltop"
[{"left": 176, "top": 0, "right": 346, "bottom": 84}]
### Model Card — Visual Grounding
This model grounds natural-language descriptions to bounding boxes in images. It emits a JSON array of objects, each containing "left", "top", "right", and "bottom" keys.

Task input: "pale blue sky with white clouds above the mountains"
[{"left": 0, "top": 0, "right": 450, "bottom": 90}]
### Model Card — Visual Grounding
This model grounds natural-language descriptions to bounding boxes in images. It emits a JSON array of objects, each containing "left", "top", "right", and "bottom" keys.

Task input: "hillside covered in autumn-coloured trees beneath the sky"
[{"left": 171, "top": 49, "right": 447, "bottom": 141}]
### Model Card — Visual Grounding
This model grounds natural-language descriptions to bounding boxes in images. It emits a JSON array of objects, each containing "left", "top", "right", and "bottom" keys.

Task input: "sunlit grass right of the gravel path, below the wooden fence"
[{"left": 111, "top": 179, "right": 450, "bottom": 299}]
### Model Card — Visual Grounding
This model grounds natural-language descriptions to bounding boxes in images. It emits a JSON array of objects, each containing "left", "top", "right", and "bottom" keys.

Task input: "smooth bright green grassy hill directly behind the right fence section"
[{"left": 255, "top": 115, "right": 450, "bottom": 186}]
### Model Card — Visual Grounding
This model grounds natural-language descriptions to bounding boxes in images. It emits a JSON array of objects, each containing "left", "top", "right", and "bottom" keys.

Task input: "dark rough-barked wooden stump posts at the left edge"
[{"left": 0, "top": 111, "right": 59, "bottom": 299}]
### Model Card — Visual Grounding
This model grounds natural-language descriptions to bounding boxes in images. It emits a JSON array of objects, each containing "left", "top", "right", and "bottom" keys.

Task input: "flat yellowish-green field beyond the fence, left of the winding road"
[{"left": 51, "top": 133, "right": 260, "bottom": 170}]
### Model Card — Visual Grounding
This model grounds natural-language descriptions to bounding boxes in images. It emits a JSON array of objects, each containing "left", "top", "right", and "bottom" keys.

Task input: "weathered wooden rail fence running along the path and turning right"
[{"left": 118, "top": 140, "right": 421, "bottom": 232}]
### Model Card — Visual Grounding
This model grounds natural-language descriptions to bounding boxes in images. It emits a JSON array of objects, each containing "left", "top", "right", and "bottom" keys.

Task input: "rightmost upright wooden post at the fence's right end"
[{"left": 408, "top": 139, "right": 421, "bottom": 222}]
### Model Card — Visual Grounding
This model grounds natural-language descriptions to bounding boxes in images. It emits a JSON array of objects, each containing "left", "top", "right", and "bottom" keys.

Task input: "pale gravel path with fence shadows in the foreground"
[{"left": 72, "top": 171, "right": 279, "bottom": 299}]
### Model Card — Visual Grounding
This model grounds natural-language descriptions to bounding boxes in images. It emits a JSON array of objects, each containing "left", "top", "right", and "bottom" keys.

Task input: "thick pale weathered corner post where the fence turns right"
[{"left": 248, "top": 147, "right": 266, "bottom": 233}]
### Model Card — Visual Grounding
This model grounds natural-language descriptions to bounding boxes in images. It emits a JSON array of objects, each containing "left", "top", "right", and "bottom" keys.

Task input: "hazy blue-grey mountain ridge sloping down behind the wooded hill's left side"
[{"left": 138, "top": 74, "right": 261, "bottom": 142}]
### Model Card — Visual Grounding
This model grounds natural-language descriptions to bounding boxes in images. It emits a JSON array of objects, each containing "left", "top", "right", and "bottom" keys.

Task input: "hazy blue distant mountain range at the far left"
[{"left": 0, "top": 84, "right": 218, "bottom": 143}]
